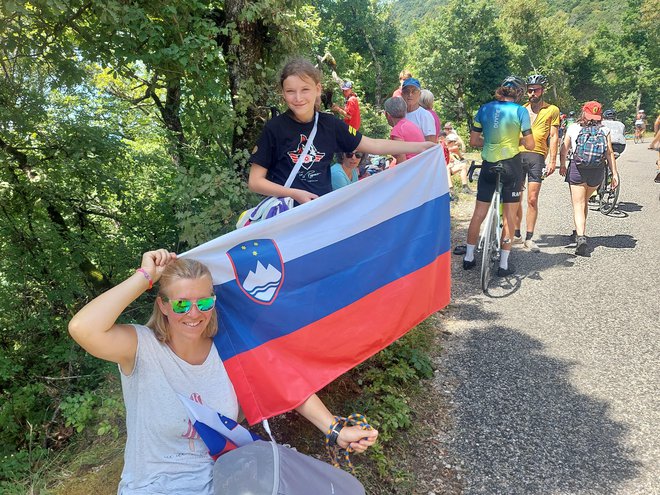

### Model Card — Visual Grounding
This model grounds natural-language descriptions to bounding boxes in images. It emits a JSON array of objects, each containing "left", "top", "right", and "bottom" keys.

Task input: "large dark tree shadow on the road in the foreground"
[{"left": 446, "top": 328, "right": 641, "bottom": 495}]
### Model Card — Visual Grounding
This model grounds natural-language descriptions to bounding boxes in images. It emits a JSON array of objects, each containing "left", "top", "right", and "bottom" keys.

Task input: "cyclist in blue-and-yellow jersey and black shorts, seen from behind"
[{"left": 463, "top": 76, "right": 535, "bottom": 277}]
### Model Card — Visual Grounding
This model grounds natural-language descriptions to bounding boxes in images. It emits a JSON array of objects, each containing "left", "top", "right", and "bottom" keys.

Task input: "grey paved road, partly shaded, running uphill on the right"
[{"left": 437, "top": 142, "right": 660, "bottom": 495}]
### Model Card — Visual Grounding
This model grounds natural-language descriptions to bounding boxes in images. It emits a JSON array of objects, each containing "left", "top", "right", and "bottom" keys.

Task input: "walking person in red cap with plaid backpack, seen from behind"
[{"left": 559, "top": 101, "right": 619, "bottom": 256}]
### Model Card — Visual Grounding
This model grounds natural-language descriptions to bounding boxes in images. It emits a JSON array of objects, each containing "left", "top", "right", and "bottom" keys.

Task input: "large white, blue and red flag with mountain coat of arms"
[{"left": 183, "top": 146, "right": 450, "bottom": 424}]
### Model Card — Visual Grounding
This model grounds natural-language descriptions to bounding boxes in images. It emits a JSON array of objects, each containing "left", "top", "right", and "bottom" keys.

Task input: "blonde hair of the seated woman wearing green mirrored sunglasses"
[{"left": 147, "top": 258, "right": 218, "bottom": 343}]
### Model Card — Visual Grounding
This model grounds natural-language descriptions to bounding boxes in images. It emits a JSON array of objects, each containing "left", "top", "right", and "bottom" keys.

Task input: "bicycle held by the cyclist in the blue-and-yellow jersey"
[{"left": 468, "top": 161, "right": 504, "bottom": 294}]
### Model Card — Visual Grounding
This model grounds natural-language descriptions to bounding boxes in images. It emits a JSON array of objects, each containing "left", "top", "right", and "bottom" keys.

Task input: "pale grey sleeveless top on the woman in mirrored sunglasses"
[{"left": 117, "top": 325, "right": 238, "bottom": 495}]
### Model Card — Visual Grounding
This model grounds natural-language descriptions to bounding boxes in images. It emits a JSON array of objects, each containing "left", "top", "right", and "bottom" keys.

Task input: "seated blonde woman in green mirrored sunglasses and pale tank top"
[{"left": 69, "top": 249, "right": 378, "bottom": 495}]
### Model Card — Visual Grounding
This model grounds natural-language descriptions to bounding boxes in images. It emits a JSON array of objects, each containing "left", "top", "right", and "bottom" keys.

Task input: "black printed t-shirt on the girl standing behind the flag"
[{"left": 250, "top": 112, "right": 362, "bottom": 196}]
